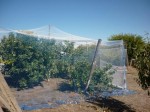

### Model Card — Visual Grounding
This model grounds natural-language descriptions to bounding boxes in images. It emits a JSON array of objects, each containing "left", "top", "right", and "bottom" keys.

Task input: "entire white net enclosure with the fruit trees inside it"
[{"left": 0, "top": 26, "right": 126, "bottom": 110}]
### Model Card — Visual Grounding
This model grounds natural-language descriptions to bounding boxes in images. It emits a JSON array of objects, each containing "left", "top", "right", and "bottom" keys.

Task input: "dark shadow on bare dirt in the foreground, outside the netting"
[{"left": 87, "top": 98, "right": 135, "bottom": 112}]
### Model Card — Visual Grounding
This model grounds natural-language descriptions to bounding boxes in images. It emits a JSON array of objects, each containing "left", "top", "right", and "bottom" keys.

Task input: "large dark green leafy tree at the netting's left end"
[{"left": 0, "top": 34, "right": 43, "bottom": 88}]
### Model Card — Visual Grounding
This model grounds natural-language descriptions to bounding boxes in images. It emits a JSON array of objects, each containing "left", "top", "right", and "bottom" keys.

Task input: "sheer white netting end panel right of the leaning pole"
[{"left": 98, "top": 41, "right": 126, "bottom": 88}]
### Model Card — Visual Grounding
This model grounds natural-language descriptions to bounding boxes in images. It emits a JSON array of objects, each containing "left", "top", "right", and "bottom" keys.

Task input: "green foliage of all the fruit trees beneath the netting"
[{"left": 0, "top": 34, "right": 111, "bottom": 91}]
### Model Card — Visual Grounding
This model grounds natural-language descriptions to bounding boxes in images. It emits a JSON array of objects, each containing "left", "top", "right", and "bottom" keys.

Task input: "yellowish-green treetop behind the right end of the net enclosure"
[{"left": 109, "top": 34, "right": 144, "bottom": 62}]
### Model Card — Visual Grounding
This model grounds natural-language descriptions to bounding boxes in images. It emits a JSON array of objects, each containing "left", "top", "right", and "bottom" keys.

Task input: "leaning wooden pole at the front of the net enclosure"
[{"left": 84, "top": 39, "right": 102, "bottom": 92}]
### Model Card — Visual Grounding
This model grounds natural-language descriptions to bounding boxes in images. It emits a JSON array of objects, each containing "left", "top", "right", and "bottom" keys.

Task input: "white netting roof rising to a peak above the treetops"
[{"left": 0, "top": 25, "right": 96, "bottom": 43}]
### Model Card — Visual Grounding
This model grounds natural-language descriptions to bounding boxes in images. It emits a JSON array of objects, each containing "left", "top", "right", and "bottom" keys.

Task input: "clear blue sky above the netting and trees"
[{"left": 0, "top": 0, "right": 150, "bottom": 40}]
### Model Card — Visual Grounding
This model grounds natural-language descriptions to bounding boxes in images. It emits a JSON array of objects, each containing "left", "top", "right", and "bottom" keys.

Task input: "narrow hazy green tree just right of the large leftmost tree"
[{"left": 39, "top": 39, "right": 60, "bottom": 80}]
